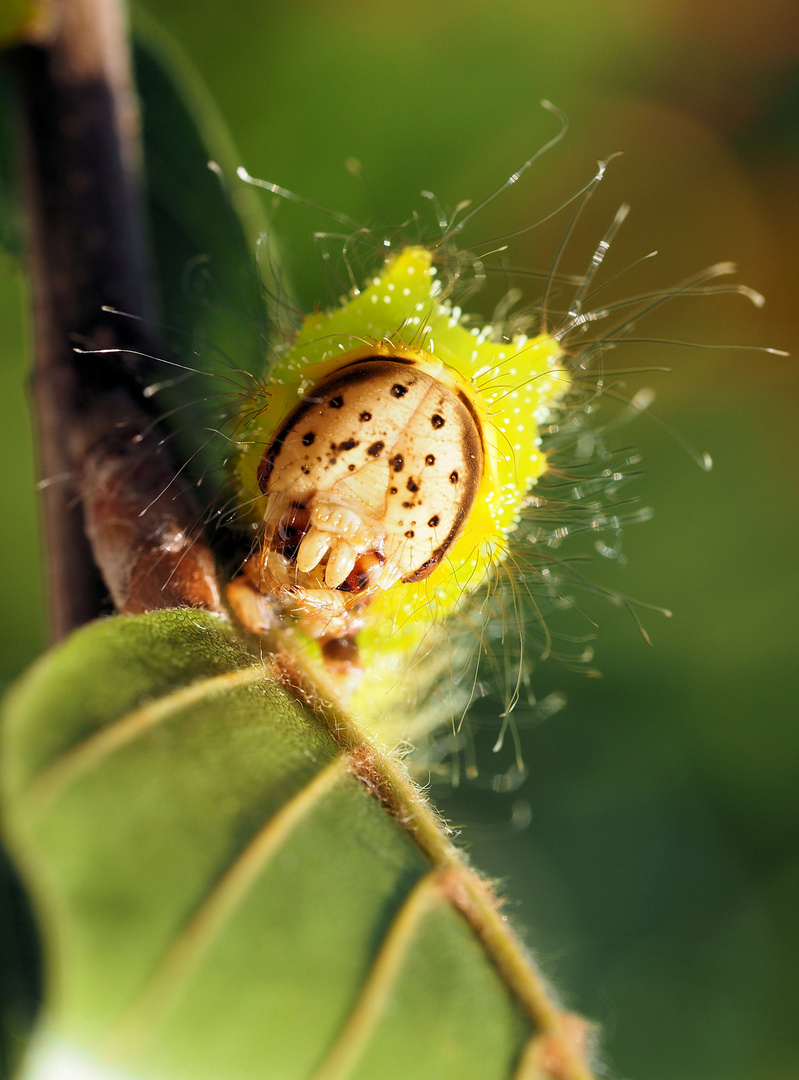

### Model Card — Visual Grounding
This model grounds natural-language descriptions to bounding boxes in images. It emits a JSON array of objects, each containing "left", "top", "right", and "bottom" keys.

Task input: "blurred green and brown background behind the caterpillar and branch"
[{"left": 0, "top": 0, "right": 799, "bottom": 1080}]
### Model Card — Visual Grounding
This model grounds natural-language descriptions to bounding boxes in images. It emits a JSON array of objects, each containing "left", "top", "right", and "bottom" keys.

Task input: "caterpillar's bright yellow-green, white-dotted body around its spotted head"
[{"left": 238, "top": 246, "right": 570, "bottom": 712}]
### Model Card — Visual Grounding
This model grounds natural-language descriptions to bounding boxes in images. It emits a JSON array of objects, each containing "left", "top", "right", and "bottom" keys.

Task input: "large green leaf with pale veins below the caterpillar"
[{"left": 2, "top": 610, "right": 574, "bottom": 1080}]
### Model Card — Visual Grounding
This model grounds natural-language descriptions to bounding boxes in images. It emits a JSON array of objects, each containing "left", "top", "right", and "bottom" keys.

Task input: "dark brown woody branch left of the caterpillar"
[{"left": 14, "top": 0, "right": 219, "bottom": 639}]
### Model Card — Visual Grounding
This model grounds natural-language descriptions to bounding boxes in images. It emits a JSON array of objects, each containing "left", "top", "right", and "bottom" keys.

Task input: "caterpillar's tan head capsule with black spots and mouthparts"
[{"left": 252, "top": 354, "right": 484, "bottom": 638}]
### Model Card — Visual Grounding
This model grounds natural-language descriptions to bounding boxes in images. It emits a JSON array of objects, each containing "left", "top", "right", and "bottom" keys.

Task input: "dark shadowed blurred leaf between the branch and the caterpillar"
[{"left": 134, "top": 24, "right": 274, "bottom": 494}]
